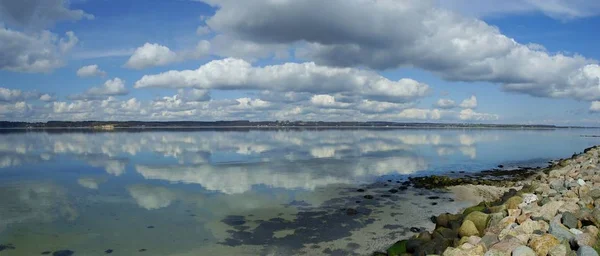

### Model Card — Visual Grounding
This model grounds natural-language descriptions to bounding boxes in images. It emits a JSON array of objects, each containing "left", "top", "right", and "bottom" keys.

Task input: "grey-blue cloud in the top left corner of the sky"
[{"left": 0, "top": 0, "right": 94, "bottom": 28}]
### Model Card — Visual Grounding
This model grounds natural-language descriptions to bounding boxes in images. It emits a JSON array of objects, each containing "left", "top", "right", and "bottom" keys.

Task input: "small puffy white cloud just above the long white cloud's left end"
[{"left": 125, "top": 40, "right": 210, "bottom": 69}]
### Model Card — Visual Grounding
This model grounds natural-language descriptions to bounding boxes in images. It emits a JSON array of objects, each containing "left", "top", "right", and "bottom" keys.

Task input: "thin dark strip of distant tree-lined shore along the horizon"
[{"left": 0, "top": 120, "right": 569, "bottom": 129}]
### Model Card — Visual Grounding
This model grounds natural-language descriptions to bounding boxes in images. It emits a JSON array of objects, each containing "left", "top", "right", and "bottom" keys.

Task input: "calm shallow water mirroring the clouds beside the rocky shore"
[{"left": 0, "top": 129, "right": 600, "bottom": 255}]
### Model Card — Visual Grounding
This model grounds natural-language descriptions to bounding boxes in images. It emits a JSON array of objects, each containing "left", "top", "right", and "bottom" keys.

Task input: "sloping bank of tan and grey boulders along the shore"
[{"left": 375, "top": 147, "right": 600, "bottom": 256}]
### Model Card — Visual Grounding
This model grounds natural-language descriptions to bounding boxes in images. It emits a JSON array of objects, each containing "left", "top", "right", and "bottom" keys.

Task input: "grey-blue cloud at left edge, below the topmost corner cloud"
[{"left": 0, "top": 24, "right": 78, "bottom": 73}]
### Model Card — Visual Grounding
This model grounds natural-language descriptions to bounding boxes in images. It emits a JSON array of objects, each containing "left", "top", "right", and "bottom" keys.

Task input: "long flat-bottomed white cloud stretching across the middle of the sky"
[{"left": 134, "top": 58, "right": 429, "bottom": 102}]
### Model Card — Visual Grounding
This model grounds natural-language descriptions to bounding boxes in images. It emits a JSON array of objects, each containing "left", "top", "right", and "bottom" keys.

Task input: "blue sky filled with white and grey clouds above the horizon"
[{"left": 0, "top": 0, "right": 600, "bottom": 126}]
